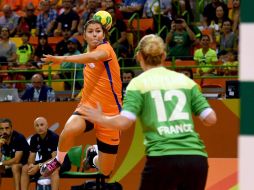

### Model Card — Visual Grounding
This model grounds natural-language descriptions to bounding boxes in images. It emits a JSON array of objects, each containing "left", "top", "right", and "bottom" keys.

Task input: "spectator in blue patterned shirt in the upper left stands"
[{"left": 36, "top": 0, "right": 57, "bottom": 36}]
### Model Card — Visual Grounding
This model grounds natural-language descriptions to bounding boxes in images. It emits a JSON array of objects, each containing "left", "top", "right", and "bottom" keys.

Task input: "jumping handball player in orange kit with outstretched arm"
[{"left": 40, "top": 19, "right": 122, "bottom": 176}]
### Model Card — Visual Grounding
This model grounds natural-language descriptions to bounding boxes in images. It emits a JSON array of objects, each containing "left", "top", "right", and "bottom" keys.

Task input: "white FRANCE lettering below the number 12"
[{"left": 157, "top": 124, "right": 194, "bottom": 135}]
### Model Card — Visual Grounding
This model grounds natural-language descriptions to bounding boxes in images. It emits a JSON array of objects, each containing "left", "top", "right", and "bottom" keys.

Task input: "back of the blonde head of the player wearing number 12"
[{"left": 138, "top": 34, "right": 165, "bottom": 65}]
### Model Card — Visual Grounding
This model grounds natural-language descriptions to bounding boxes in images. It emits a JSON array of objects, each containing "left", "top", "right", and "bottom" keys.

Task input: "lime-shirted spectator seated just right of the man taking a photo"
[{"left": 194, "top": 35, "right": 218, "bottom": 76}]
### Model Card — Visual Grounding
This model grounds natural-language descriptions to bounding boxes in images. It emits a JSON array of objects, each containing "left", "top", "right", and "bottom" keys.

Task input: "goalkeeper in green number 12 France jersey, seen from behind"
[{"left": 83, "top": 34, "right": 217, "bottom": 190}]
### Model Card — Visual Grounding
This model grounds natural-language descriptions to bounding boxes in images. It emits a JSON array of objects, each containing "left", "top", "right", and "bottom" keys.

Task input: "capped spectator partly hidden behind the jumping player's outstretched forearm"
[{"left": 60, "top": 38, "right": 84, "bottom": 89}]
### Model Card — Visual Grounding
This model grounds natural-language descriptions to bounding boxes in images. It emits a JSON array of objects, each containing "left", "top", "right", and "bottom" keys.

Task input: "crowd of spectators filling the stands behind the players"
[{"left": 0, "top": 0, "right": 240, "bottom": 95}]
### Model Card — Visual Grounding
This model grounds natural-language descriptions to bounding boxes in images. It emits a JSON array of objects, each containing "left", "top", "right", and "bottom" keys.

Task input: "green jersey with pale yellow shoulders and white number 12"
[{"left": 121, "top": 67, "right": 210, "bottom": 156}]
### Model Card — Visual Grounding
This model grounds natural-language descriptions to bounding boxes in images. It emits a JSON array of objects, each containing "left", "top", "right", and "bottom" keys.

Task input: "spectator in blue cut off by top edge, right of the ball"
[{"left": 120, "top": 0, "right": 145, "bottom": 19}]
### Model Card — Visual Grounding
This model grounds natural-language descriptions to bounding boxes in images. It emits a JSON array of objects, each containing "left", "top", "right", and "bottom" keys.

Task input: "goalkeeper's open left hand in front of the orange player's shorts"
[{"left": 81, "top": 103, "right": 104, "bottom": 123}]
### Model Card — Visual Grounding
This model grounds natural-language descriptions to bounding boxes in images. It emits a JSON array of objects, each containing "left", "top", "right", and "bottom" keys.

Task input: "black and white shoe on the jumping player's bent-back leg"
[{"left": 84, "top": 145, "right": 98, "bottom": 170}]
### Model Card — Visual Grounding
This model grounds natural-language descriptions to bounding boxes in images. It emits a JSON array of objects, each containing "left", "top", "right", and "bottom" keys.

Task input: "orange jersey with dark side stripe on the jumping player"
[{"left": 76, "top": 42, "right": 122, "bottom": 115}]
